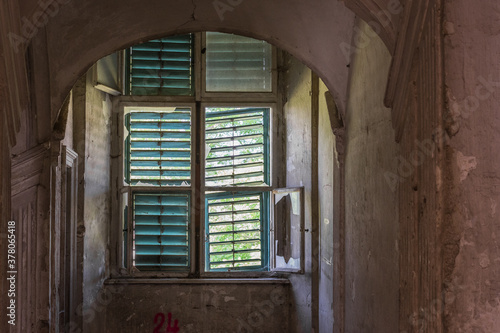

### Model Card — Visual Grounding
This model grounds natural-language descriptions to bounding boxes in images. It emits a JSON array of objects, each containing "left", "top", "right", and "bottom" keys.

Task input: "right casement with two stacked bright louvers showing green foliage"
[{"left": 205, "top": 107, "right": 271, "bottom": 271}]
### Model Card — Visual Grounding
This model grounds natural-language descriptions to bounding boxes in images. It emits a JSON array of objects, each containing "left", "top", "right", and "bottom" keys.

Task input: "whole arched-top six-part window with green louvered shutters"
[{"left": 112, "top": 32, "right": 303, "bottom": 276}]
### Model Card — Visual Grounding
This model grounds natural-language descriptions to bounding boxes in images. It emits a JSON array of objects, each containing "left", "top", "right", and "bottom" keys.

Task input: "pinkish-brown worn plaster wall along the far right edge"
[{"left": 443, "top": 0, "right": 500, "bottom": 332}]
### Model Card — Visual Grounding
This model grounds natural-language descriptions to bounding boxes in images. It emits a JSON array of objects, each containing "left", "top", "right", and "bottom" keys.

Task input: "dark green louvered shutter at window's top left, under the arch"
[{"left": 128, "top": 34, "right": 194, "bottom": 96}]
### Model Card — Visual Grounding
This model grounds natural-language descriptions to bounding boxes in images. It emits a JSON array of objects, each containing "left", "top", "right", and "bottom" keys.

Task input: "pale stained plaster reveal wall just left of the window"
[{"left": 74, "top": 75, "right": 111, "bottom": 332}]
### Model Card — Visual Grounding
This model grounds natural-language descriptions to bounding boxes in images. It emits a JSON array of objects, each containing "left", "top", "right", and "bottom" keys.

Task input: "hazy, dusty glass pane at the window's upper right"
[{"left": 206, "top": 32, "right": 272, "bottom": 92}]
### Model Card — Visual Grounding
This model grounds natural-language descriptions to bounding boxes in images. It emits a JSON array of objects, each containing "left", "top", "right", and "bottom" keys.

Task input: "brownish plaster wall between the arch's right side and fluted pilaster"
[{"left": 345, "top": 21, "right": 399, "bottom": 332}]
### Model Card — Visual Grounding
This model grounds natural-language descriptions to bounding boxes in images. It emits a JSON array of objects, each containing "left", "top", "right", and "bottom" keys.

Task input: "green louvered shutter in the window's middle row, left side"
[{"left": 125, "top": 108, "right": 191, "bottom": 186}]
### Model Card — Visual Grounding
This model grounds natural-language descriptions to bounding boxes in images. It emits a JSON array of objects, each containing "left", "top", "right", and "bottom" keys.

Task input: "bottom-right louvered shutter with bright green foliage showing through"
[{"left": 206, "top": 193, "right": 269, "bottom": 271}]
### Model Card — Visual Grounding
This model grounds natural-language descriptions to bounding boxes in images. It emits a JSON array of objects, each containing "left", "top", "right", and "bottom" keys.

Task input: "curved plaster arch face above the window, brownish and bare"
[{"left": 24, "top": 0, "right": 394, "bottom": 120}]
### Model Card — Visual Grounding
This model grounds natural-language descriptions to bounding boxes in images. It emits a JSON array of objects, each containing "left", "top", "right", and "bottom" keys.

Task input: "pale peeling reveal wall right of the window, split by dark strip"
[{"left": 284, "top": 53, "right": 338, "bottom": 332}]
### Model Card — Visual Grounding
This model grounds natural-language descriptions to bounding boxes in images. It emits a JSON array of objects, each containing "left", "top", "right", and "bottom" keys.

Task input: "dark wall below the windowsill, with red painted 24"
[{"left": 101, "top": 281, "right": 289, "bottom": 333}]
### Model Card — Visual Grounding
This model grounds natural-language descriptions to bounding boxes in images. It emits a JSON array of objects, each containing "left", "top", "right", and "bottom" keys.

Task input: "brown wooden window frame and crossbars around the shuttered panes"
[{"left": 110, "top": 33, "right": 303, "bottom": 278}]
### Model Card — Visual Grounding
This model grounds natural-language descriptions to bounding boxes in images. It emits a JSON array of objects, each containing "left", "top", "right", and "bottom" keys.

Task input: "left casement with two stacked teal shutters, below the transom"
[{"left": 123, "top": 106, "right": 192, "bottom": 272}]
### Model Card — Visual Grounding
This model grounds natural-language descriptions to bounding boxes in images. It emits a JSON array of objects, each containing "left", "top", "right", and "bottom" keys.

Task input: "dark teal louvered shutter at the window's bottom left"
[{"left": 133, "top": 193, "right": 190, "bottom": 271}]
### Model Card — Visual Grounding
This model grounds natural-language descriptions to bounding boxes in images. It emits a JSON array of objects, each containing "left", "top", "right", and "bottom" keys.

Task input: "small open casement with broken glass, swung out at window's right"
[{"left": 270, "top": 187, "right": 305, "bottom": 273}]
